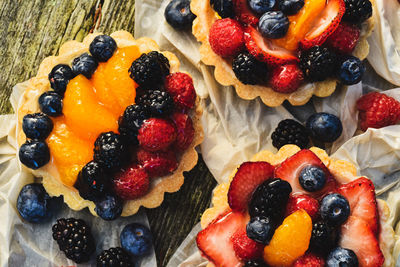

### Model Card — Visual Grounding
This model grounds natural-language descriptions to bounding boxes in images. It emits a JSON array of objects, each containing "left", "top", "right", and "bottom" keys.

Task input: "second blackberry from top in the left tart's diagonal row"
[{"left": 136, "top": 90, "right": 174, "bottom": 117}]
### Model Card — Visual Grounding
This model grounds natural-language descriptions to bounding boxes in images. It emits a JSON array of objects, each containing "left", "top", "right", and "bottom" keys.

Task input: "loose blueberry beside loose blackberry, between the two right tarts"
[{"left": 306, "top": 112, "right": 343, "bottom": 143}]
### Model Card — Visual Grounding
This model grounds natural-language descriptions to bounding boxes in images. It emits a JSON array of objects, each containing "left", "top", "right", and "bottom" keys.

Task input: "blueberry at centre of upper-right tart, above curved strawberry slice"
[{"left": 258, "top": 11, "right": 289, "bottom": 39}]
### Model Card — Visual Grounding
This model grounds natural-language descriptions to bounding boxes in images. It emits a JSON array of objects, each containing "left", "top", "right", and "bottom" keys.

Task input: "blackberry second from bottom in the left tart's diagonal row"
[{"left": 93, "top": 132, "right": 127, "bottom": 170}]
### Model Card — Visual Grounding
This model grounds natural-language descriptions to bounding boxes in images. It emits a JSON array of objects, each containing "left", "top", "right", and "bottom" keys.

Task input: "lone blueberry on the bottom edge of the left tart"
[{"left": 94, "top": 194, "right": 122, "bottom": 221}]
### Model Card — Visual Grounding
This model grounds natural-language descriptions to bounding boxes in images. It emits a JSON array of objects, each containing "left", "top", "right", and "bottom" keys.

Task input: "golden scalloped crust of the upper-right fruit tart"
[{"left": 190, "top": 0, "right": 376, "bottom": 107}]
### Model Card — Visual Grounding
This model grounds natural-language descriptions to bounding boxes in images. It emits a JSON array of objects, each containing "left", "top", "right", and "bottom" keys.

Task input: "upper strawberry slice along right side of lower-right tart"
[{"left": 339, "top": 177, "right": 379, "bottom": 234}]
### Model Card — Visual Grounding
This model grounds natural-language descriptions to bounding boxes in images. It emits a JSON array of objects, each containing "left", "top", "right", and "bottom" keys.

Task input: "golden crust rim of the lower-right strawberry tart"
[{"left": 201, "top": 145, "right": 395, "bottom": 267}]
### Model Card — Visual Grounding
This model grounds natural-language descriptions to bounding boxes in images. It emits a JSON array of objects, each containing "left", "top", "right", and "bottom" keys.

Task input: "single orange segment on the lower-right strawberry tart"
[{"left": 264, "top": 210, "right": 312, "bottom": 266}]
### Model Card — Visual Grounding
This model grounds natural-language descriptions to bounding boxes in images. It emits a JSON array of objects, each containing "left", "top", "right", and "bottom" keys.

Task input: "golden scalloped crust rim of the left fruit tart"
[{"left": 16, "top": 31, "right": 204, "bottom": 216}]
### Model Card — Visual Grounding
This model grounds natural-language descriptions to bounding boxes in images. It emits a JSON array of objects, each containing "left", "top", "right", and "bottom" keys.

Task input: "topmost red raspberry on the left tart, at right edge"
[{"left": 165, "top": 72, "right": 196, "bottom": 110}]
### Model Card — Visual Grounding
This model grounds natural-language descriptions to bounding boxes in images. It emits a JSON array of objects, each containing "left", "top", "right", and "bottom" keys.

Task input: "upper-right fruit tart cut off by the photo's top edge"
[{"left": 191, "top": 0, "right": 374, "bottom": 107}]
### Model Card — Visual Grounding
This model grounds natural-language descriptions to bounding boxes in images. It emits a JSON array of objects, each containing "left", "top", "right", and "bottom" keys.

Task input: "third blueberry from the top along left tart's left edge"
[{"left": 49, "top": 64, "right": 75, "bottom": 96}]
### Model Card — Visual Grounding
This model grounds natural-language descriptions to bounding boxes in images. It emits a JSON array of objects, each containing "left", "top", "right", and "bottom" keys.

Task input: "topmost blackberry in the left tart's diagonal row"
[{"left": 129, "top": 51, "right": 169, "bottom": 88}]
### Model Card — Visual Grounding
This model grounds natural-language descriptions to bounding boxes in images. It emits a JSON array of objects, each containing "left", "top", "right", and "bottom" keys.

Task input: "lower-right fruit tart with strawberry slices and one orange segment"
[{"left": 197, "top": 145, "right": 394, "bottom": 267}]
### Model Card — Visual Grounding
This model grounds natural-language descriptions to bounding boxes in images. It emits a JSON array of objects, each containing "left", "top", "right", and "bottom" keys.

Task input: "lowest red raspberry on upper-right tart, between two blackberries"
[{"left": 270, "top": 64, "right": 304, "bottom": 93}]
